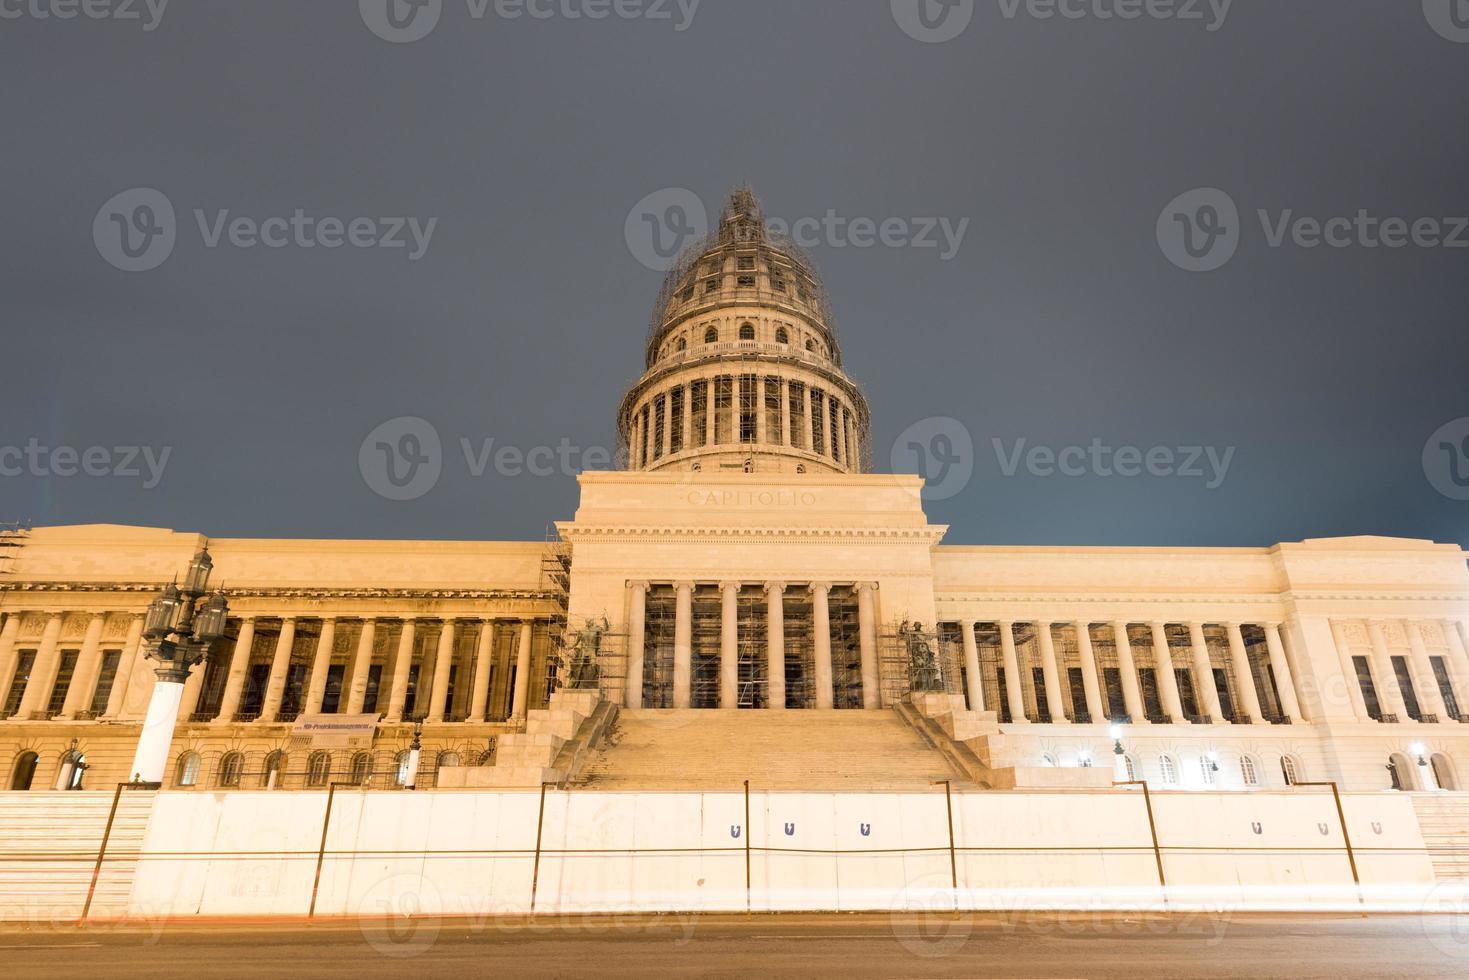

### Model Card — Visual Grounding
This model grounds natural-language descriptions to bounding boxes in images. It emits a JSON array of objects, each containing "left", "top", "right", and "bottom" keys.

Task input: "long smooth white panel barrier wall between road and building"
[{"left": 114, "top": 790, "right": 1434, "bottom": 918}]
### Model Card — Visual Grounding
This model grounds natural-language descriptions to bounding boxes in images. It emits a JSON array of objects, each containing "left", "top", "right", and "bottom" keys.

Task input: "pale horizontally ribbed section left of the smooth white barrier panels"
[{"left": 0, "top": 790, "right": 154, "bottom": 924}]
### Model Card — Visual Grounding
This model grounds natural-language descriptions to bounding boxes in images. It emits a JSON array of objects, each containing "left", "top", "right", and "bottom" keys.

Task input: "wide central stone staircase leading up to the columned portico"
[{"left": 574, "top": 710, "right": 959, "bottom": 792}]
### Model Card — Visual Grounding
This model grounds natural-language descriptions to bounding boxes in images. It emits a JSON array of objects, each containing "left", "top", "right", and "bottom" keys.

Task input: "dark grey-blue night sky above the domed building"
[{"left": 0, "top": 0, "right": 1469, "bottom": 545}]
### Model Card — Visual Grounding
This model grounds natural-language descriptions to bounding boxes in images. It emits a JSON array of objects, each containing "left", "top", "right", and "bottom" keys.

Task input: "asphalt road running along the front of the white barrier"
[{"left": 0, "top": 914, "right": 1469, "bottom": 980}]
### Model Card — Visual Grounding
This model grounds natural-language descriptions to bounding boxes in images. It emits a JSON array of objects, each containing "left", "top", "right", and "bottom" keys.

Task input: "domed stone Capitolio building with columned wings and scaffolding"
[{"left": 0, "top": 191, "right": 1469, "bottom": 811}]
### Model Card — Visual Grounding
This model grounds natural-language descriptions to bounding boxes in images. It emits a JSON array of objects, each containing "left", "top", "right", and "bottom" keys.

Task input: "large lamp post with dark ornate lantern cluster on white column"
[{"left": 132, "top": 548, "right": 229, "bottom": 783}]
